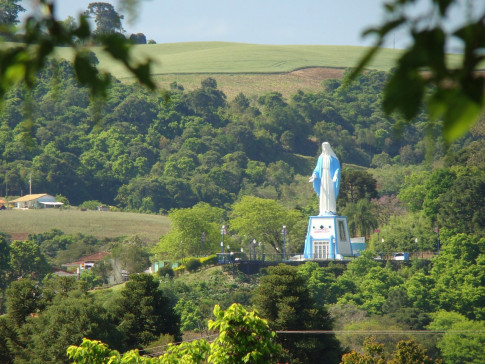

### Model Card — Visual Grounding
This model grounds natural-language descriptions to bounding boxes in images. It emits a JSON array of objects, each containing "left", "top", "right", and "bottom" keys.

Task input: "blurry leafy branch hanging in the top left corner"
[{"left": 0, "top": 0, "right": 156, "bottom": 98}]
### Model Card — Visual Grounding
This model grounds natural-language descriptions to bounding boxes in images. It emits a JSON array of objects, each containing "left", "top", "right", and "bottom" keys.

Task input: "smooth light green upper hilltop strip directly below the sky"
[{"left": 54, "top": 42, "right": 464, "bottom": 78}]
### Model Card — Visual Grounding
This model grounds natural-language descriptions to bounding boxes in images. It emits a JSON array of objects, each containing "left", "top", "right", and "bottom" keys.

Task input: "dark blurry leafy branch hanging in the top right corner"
[{"left": 350, "top": 0, "right": 485, "bottom": 142}]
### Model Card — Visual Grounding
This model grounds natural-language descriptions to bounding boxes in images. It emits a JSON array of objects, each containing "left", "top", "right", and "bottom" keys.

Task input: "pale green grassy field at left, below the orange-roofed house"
[{"left": 0, "top": 209, "right": 170, "bottom": 242}]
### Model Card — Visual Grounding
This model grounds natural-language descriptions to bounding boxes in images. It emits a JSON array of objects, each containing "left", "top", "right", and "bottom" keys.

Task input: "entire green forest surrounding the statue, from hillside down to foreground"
[{"left": 0, "top": 55, "right": 485, "bottom": 363}]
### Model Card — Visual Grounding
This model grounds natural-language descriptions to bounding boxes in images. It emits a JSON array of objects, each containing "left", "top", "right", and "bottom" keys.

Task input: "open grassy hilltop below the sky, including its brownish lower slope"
[{"left": 52, "top": 42, "right": 466, "bottom": 100}]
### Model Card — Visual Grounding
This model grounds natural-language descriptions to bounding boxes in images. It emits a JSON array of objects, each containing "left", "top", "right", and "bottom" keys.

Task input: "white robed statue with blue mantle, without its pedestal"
[{"left": 309, "top": 142, "right": 340, "bottom": 216}]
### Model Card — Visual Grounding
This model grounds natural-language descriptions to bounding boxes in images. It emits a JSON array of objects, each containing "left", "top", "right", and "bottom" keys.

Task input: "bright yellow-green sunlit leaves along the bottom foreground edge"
[{"left": 67, "top": 304, "right": 281, "bottom": 364}]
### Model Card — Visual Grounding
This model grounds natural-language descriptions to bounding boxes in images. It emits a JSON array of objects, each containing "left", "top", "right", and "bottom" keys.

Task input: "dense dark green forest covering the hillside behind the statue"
[{"left": 0, "top": 57, "right": 466, "bottom": 212}]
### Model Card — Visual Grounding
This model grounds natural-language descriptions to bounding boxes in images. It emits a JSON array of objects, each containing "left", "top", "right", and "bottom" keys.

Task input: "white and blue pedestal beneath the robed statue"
[{"left": 303, "top": 214, "right": 353, "bottom": 260}]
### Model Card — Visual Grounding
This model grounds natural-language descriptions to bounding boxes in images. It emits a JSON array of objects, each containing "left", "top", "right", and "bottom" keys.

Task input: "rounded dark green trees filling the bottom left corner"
[{"left": 0, "top": 274, "right": 181, "bottom": 363}]
